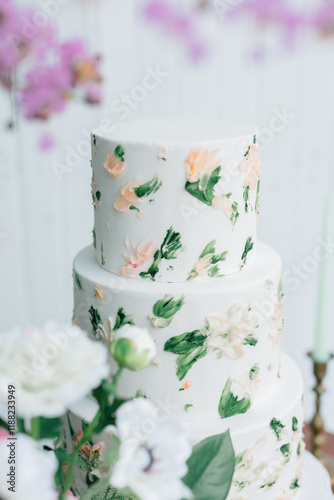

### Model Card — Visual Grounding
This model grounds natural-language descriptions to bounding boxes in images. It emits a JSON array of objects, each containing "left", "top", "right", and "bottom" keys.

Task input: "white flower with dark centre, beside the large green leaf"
[{"left": 110, "top": 398, "right": 192, "bottom": 500}]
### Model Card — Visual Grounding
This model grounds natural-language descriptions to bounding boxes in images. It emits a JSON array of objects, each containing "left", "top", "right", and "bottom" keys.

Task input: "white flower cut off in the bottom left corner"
[{"left": 0, "top": 430, "right": 58, "bottom": 500}]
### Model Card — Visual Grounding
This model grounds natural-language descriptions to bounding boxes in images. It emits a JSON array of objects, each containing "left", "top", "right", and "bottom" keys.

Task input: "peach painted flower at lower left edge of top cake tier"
[{"left": 118, "top": 238, "right": 157, "bottom": 278}]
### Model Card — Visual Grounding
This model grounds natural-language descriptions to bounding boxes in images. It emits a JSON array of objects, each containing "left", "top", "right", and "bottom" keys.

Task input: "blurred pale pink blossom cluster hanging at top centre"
[{"left": 144, "top": 0, "right": 208, "bottom": 62}]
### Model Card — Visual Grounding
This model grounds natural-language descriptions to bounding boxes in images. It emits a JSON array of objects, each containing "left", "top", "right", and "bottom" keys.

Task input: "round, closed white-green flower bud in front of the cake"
[{"left": 110, "top": 325, "right": 156, "bottom": 371}]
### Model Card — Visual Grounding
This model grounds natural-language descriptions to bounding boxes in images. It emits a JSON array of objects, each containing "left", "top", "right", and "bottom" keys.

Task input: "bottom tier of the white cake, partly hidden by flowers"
[{"left": 69, "top": 354, "right": 304, "bottom": 500}]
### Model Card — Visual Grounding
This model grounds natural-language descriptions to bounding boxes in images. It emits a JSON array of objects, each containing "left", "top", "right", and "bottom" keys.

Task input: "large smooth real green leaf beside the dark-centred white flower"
[{"left": 183, "top": 431, "right": 235, "bottom": 500}]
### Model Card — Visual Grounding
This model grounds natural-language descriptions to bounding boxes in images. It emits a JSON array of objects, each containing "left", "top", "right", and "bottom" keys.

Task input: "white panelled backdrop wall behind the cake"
[{"left": 0, "top": 0, "right": 334, "bottom": 431}]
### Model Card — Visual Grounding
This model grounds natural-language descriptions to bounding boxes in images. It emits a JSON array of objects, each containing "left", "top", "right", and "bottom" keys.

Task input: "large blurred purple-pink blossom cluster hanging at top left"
[{"left": 0, "top": 1, "right": 102, "bottom": 120}]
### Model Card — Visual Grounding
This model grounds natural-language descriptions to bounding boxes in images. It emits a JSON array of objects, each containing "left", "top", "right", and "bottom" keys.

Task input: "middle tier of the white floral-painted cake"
[{"left": 74, "top": 243, "right": 283, "bottom": 420}]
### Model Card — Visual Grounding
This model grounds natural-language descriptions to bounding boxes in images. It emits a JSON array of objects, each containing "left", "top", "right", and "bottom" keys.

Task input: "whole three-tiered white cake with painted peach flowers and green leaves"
[{"left": 73, "top": 120, "right": 304, "bottom": 500}]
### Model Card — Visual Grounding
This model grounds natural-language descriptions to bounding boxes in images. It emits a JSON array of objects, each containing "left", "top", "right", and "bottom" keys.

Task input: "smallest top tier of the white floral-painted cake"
[{"left": 92, "top": 119, "right": 260, "bottom": 282}]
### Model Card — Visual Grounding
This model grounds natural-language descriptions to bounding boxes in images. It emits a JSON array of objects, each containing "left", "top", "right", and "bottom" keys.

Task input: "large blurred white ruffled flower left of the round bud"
[{"left": 0, "top": 323, "right": 110, "bottom": 418}]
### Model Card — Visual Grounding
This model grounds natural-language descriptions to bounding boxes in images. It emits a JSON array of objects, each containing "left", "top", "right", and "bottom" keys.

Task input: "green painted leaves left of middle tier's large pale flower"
[{"left": 164, "top": 328, "right": 207, "bottom": 380}]
